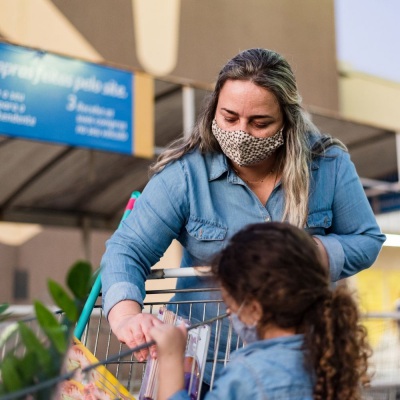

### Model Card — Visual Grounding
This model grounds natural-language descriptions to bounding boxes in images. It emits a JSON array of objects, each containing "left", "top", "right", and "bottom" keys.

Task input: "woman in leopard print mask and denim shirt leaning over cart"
[{"left": 102, "top": 49, "right": 385, "bottom": 379}]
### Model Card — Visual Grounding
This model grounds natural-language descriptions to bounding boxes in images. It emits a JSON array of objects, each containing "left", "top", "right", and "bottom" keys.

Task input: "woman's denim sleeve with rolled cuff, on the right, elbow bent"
[{"left": 316, "top": 150, "right": 386, "bottom": 281}]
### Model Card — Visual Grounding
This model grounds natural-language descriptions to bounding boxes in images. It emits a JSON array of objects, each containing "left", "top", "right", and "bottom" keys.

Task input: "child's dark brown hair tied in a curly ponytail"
[{"left": 212, "top": 222, "right": 371, "bottom": 400}]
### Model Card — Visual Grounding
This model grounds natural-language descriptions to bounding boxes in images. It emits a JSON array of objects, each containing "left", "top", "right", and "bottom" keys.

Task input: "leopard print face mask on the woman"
[{"left": 212, "top": 119, "right": 284, "bottom": 166}]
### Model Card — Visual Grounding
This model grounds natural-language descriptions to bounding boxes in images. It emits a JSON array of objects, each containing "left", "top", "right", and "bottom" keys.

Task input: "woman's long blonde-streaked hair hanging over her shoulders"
[{"left": 151, "top": 48, "right": 344, "bottom": 227}]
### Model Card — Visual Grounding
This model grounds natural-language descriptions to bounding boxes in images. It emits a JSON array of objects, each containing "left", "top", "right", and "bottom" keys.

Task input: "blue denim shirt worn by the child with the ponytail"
[{"left": 169, "top": 335, "right": 314, "bottom": 400}]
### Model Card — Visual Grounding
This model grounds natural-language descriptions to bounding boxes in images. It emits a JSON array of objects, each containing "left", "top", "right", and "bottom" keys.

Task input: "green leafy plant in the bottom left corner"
[{"left": 0, "top": 261, "right": 92, "bottom": 400}]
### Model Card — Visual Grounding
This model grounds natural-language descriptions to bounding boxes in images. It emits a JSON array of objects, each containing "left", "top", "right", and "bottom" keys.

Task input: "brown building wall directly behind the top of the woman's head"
[{"left": 177, "top": 0, "right": 338, "bottom": 111}]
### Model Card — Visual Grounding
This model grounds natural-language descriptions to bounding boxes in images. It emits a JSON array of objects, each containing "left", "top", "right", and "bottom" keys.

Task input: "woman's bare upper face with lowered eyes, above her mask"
[{"left": 215, "top": 80, "right": 283, "bottom": 138}]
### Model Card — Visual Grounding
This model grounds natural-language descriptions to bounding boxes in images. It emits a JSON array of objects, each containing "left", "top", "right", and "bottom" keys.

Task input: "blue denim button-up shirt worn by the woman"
[{"left": 101, "top": 139, "right": 385, "bottom": 315}]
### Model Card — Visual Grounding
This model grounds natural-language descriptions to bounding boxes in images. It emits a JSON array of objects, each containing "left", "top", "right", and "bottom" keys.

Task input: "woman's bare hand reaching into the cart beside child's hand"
[{"left": 108, "top": 300, "right": 163, "bottom": 361}]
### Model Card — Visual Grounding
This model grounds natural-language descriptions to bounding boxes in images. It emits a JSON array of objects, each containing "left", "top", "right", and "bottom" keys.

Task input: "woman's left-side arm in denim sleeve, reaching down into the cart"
[{"left": 101, "top": 163, "right": 187, "bottom": 359}]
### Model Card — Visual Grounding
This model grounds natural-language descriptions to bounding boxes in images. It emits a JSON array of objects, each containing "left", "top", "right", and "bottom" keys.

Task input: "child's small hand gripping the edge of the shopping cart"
[{"left": 150, "top": 323, "right": 187, "bottom": 359}]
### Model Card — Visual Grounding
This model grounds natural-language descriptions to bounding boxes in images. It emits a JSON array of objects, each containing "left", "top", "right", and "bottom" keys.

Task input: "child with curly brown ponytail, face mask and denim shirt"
[{"left": 150, "top": 222, "right": 370, "bottom": 400}]
